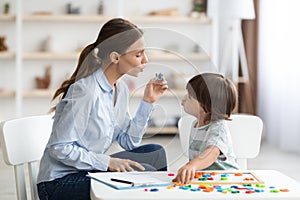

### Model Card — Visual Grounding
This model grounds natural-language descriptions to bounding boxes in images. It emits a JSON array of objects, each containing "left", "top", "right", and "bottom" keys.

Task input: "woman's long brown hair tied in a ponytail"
[{"left": 50, "top": 18, "right": 143, "bottom": 112}]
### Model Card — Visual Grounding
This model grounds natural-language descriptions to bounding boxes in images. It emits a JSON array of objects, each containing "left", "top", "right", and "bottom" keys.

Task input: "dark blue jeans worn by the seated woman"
[{"left": 37, "top": 144, "right": 167, "bottom": 200}]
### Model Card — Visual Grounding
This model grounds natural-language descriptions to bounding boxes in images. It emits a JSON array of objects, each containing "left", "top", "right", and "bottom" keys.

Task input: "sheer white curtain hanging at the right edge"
[{"left": 258, "top": 0, "right": 300, "bottom": 153}]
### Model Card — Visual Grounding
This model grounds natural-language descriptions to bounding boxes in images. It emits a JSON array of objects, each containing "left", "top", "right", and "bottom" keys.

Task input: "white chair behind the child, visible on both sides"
[{"left": 178, "top": 114, "right": 263, "bottom": 170}]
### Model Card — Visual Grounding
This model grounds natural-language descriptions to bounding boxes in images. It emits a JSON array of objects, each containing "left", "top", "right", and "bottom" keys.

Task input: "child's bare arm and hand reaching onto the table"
[{"left": 173, "top": 146, "right": 220, "bottom": 183}]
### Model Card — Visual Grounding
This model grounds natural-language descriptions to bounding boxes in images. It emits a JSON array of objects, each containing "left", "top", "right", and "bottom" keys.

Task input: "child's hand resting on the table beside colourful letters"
[{"left": 173, "top": 162, "right": 196, "bottom": 184}]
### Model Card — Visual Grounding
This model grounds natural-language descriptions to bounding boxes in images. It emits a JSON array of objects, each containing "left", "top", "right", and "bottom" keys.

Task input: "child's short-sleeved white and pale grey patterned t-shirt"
[{"left": 189, "top": 120, "right": 239, "bottom": 170}]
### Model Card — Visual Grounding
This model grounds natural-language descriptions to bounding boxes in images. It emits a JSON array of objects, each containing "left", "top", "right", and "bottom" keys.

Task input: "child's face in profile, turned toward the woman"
[{"left": 181, "top": 94, "right": 202, "bottom": 118}]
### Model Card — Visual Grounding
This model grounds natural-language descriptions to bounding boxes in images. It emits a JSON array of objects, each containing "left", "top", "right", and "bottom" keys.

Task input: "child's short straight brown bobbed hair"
[{"left": 186, "top": 73, "right": 237, "bottom": 121}]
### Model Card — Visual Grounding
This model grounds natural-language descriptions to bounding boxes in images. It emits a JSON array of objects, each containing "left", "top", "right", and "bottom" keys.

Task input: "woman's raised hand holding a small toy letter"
[{"left": 143, "top": 73, "right": 168, "bottom": 103}]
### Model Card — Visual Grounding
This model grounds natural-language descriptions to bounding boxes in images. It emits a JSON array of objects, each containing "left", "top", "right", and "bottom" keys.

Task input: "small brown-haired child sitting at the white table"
[{"left": 173, "top": 73, "right": 238, "bottom": 183}]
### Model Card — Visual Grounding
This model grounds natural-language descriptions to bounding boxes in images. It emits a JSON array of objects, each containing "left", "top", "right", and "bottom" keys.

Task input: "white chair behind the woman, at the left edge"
[{"left": 0, "top": 115, "right": 53, "bottom": 200}]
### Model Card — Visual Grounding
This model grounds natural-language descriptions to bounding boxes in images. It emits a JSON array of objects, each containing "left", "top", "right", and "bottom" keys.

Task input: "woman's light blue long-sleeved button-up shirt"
[{"left": 37, "top": 69, "right": 153, "bottom": 183}]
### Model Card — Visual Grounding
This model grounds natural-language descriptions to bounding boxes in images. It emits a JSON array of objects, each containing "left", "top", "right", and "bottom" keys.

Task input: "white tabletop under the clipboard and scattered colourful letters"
[{"left": 91, "top": 170, "right": 300, "bottom": 200}]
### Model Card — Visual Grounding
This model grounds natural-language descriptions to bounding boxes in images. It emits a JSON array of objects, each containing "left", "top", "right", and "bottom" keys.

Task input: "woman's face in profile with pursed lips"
[{"left": 118, "top": 38, "right": 148, "bottom": 77}]
